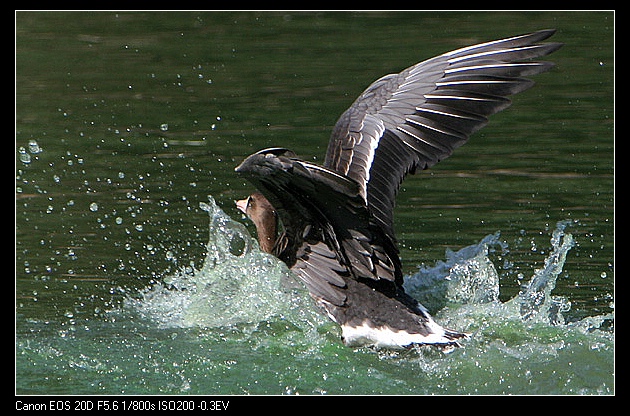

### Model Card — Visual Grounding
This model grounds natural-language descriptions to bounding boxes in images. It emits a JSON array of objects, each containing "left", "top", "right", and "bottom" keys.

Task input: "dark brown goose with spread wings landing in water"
[{"left": 235, "top": 29, "right": 563, "bottom": 352}]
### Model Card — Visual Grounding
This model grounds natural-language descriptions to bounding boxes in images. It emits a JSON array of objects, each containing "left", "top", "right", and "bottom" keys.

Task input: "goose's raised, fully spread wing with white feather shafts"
[{"left": 324, "top": 30, "right": 562, "bottom": 241}]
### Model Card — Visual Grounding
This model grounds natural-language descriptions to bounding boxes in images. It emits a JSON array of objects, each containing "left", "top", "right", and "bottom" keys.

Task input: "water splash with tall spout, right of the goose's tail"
[{"left": 404, "top": 220, "right": 614, "bottom": 330}]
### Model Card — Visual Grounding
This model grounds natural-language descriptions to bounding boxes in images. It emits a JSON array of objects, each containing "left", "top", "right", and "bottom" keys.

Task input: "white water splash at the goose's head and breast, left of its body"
[{"left": 127, "top": 196, "right": 328, "bottom": 336}]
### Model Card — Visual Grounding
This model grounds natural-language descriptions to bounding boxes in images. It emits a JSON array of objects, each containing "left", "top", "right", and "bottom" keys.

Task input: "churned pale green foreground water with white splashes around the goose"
[{"left": 22, "top": 198, "right": 614, "bottom": 395}]
